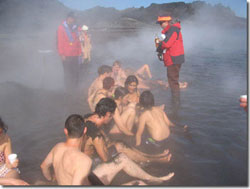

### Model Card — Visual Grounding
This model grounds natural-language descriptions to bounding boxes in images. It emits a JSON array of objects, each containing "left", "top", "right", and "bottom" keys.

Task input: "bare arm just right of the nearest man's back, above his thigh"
[{"left": 93, "top": 136, "right": 108, "bottom": 162}]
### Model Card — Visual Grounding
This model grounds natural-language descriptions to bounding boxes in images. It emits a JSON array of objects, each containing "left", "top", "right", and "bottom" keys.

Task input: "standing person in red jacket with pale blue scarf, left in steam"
[{"left": 57, "top": 12, "right": 81, "bottom": 93}]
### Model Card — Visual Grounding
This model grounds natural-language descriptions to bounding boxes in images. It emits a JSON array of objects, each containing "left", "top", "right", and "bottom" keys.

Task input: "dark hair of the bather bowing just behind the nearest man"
[{"left": 95, "top": 98, "right": 116, "bottom": 117}]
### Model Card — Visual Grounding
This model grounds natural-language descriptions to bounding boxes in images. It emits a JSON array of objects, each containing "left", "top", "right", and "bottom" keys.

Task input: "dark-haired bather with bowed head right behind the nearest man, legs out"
[{"left": 82, "top": 98, "right": 172, "bottom": 162}]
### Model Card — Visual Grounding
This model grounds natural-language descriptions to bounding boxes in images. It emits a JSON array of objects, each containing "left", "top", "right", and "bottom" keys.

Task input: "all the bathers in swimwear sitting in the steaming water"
[{"left": 0, "top": 61, "right": 187, "bottom": 185}]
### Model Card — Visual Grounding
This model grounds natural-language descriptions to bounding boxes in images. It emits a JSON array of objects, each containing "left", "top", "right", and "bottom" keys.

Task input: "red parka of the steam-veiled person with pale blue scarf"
[{"left": 57, "top": 23, "right": 81, "bottom": 56}]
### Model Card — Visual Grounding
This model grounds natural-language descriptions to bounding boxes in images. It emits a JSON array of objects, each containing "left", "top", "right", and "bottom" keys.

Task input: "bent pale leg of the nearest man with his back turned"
[{"left": 93, "top": 154, "right": 174, "bottom": 185}]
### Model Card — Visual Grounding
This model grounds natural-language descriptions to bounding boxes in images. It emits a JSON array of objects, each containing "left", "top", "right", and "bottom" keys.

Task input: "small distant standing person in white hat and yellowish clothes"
[{"left": 80, "top": 25, "right": 92, "bottom": 64}]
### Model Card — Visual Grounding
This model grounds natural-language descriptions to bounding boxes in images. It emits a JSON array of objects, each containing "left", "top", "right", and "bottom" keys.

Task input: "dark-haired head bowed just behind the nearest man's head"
[{"left": 95, "top": 98, "right": 116, "bottom": 124}]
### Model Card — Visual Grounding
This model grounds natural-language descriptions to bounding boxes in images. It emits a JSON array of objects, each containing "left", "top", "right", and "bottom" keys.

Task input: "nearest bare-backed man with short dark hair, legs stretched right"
[{"left": 41, "top": 114, "right": 174, "bottom": 185}]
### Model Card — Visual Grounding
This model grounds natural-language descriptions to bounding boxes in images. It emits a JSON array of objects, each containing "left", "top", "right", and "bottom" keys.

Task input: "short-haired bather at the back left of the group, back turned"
[{"left": 88, "top": 65, "right": 112, "bottom": 101}]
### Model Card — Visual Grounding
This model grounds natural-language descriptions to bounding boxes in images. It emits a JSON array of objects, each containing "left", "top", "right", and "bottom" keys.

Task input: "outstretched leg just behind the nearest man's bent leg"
[{"left": 115, "top": 142, "right": 172, "bottom": 163}]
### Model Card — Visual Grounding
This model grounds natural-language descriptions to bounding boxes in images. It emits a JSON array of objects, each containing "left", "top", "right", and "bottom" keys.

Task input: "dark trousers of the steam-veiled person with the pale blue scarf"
[{"left": 62, "top": 56, "right": 79, "bottom": 93}]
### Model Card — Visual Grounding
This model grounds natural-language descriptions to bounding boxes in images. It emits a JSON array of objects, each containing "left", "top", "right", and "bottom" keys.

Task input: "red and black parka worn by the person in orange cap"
[{"left": 161, "top": 23, "right": 185, "bottom": 66}]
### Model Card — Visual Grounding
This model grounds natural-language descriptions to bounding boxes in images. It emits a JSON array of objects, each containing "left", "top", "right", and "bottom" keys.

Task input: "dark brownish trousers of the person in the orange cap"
[{"left": 167, "top": 64, "right": 181, "bottom": 103}]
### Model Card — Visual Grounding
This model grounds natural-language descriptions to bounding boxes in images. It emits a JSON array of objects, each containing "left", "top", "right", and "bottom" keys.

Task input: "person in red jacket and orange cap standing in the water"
[{"left": 157, "top": 16, "right": 184, "bottom": 109}]
